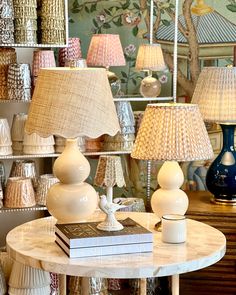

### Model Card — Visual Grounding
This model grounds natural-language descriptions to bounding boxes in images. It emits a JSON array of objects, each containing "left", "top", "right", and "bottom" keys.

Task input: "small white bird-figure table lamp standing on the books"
[{"left": 94, "top": 155, "right": 125, "bottom": 231}]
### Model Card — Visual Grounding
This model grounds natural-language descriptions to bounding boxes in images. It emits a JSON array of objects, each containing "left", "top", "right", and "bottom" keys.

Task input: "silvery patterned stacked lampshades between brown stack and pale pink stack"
[{"left": 7, "top": 63, "right": 31, "bottom": 101}]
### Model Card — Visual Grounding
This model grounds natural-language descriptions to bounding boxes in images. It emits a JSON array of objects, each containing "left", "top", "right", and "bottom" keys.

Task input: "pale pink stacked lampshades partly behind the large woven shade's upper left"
[{"left": 32, "top": 50, "right": 56, "bottom": 86}]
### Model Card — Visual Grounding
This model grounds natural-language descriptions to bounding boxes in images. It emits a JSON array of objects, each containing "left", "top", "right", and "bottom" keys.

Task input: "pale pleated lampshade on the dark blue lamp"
[{"left": 192, "top": 67, "right": 236, "bottom": 123}]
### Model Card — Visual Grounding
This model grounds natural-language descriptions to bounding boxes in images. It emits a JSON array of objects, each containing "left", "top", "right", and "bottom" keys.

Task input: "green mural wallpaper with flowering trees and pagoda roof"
[{"left": 69, "top": 0, "right": 236, "bottom": 202}]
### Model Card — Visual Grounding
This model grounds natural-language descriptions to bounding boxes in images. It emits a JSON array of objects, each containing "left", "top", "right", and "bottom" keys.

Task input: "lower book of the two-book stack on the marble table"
[{"left": 56, "top": 236, "right": 153, "bottom": 258}]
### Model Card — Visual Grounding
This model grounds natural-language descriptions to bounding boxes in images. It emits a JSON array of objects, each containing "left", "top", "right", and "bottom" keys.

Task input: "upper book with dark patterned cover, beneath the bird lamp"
[{"left": 55, "top": 218, "right": 153, "bottom": 248}]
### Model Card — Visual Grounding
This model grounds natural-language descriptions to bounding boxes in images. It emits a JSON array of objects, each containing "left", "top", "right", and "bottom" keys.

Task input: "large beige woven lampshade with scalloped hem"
[{"left": 25, "top": 68, "right": 120, "bottom": 138}]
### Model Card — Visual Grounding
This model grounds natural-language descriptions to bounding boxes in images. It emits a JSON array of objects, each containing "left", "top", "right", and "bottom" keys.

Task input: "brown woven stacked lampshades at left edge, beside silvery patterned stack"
[{"left": 0, "top": 48, "right": 16, "bottom": 99}]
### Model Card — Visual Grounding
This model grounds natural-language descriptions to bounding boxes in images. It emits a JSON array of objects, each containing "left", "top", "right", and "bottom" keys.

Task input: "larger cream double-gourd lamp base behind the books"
[{"left": 46, "top": 138, "right": 98, "bottom": 223}]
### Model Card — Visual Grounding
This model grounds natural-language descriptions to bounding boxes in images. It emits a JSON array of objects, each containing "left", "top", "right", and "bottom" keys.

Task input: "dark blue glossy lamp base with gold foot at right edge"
[{"left": 206, "top": 124, "right": 236, "bottom": 205}]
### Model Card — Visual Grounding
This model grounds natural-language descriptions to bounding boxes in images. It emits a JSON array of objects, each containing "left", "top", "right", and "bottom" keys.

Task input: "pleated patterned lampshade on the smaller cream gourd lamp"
[{"left": 131, "top": 103, "right": 213, "bottom": 161}]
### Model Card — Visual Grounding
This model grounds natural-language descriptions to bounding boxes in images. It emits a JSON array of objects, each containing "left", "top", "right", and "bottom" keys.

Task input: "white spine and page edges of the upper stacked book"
[{"left": 56, "top": 229, "right": 153, "bottom": 248}]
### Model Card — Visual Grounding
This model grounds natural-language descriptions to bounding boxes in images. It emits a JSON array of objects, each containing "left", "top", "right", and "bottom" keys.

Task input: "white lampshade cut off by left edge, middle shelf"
[{"left": 0, "top": 118, "right": 12, "bottom": 156}]
